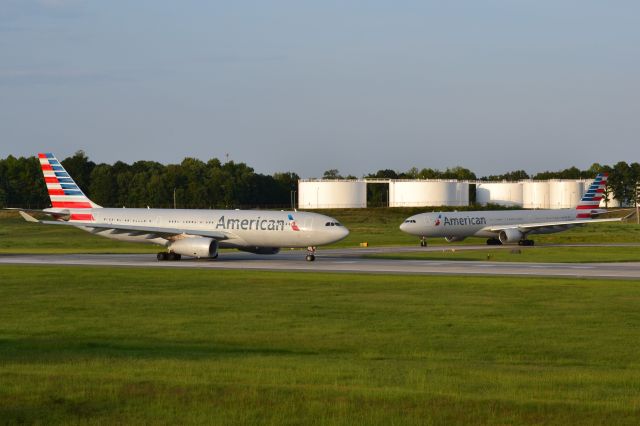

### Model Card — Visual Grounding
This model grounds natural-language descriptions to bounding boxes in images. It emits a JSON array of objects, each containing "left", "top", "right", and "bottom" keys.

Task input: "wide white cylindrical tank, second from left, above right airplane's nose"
[{"left": 389, "top": 180, "right": 469, "bottom": 207}]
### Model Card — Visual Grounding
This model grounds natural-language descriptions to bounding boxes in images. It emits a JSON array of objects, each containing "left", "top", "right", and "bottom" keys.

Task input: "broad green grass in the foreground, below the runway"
[{"left": 0, "top": 266, "right": 640, "bottom": 425}]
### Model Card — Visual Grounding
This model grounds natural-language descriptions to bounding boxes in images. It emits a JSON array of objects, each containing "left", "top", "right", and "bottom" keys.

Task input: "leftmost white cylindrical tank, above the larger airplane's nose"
[{"left": 298, "top": 179, "right": 367, "bottom": 209}]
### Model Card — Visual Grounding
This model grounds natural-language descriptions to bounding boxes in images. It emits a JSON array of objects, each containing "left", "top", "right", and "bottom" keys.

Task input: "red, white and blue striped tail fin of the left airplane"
[{"left": 38, "top": 153, "right": 100, "bottom": 213}]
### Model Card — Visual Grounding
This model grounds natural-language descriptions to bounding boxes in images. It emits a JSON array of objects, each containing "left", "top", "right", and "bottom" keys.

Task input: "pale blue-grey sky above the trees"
[{"left": 0, "top": 0, "right": 640, "bottom": 178}]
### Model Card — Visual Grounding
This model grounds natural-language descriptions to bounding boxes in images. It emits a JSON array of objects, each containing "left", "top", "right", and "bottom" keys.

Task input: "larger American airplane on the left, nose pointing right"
[{"left": 16, "top": 153, "right": 349, "bottom": 262}]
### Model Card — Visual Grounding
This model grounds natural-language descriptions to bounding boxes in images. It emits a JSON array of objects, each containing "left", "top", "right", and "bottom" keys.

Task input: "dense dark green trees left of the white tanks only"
[{"left": 0, "top": 151, "right": 299, "bottom": 209}]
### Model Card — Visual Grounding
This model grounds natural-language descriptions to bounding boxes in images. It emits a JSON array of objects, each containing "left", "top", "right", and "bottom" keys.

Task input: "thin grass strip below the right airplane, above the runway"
[{"left": 365, "top": 246, "right": 640, "bottom": 263}]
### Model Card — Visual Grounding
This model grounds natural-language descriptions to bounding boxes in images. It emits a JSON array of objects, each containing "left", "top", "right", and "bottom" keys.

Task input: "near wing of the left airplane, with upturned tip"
[{"left": 19, "top": 211, "right": 232, "bottom": 240}]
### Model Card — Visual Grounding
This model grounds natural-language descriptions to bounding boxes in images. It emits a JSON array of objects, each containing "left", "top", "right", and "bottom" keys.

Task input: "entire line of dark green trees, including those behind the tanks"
[{"left": 0, "top": 151, "right": 640, "bottom": 209}]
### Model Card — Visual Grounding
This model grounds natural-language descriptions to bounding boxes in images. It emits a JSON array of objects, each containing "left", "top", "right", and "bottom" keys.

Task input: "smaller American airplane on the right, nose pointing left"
[{"left": 400, "top": 173, "right": 623, "bottom": 246}]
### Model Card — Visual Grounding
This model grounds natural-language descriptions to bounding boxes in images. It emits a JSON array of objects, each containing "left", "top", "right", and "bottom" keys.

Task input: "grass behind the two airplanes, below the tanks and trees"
[{"left": 0, "top": 208, "right": 640, "bottom": 253}]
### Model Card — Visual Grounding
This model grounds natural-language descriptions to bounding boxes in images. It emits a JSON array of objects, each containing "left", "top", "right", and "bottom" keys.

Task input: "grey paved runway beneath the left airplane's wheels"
[{"left": 0, "top": 246, "right": 640, "bottom": 279}]
